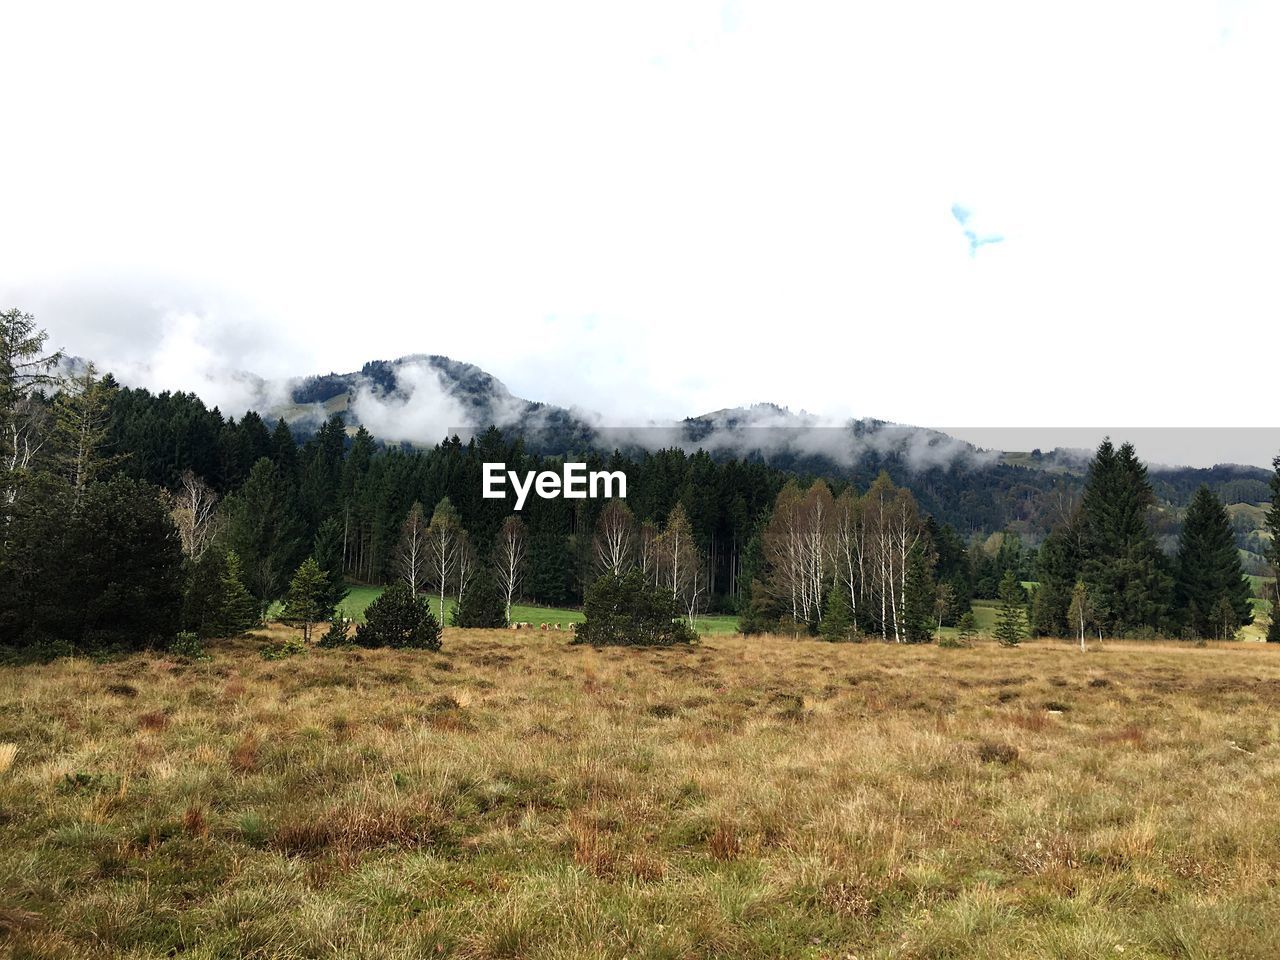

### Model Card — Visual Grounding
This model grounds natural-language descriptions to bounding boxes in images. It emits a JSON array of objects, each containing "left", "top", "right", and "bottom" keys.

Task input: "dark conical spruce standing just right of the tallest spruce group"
[{"left": 1175, "top": 486, "right": 1253, "bottom": 636}]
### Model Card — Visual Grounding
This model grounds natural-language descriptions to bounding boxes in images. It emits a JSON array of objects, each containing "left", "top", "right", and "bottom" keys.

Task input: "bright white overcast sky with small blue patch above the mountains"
[{"left": 0, "top": 0, "right": 1280, "bottom": 462}]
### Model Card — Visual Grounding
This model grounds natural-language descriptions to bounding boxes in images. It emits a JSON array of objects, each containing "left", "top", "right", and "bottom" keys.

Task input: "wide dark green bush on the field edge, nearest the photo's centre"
[{"left": 573, "top": 570, "right": 698, "bottom": 646}]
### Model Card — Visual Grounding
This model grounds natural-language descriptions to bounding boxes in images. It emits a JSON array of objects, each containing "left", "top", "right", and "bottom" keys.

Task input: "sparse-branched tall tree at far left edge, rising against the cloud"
[{"left": 0, "top": 307, "right": 63, "bottom": 508}]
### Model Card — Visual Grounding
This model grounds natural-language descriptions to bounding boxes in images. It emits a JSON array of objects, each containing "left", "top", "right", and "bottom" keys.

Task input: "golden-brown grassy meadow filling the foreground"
[{"left": 0, "top": 630, "right": 1280, "bottom": 960}]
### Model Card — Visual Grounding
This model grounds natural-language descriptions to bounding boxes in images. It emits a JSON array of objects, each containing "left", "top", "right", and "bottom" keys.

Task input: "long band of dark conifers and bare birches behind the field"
[{"left": 0, "top": 310, "right": 1280, "bottom": 660}]
